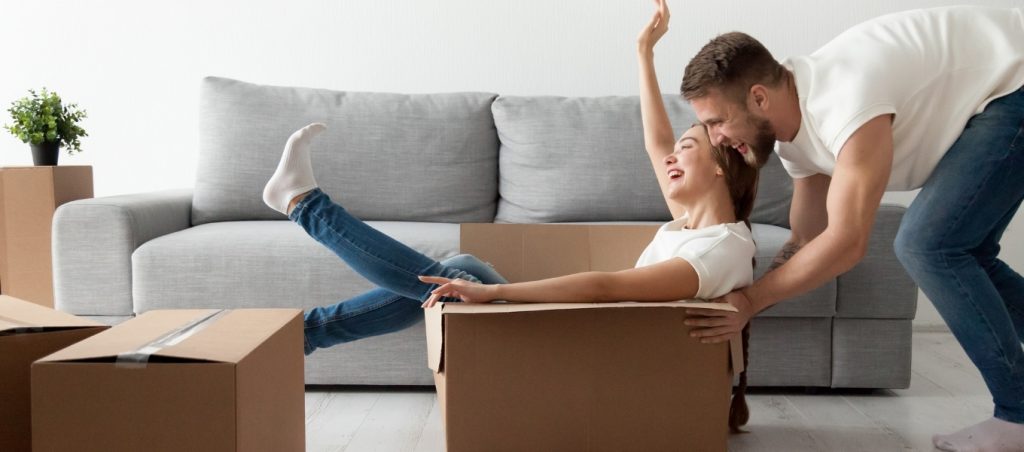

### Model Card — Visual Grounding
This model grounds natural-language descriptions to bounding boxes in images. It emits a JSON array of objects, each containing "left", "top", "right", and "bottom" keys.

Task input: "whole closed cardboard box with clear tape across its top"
[{"left": 32, "top": 310, "right": 305, "bottom": 452}]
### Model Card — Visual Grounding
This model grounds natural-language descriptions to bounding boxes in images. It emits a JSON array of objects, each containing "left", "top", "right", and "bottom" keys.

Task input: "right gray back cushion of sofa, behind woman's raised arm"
[{"left": 492, "top": 95, "right": 793, "bottom": 227}]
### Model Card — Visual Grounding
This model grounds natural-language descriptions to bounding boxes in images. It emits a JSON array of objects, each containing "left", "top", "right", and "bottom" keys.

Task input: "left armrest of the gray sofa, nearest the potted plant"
[{"left": 53, "top": 189, "right": 193, "bottom": 316}]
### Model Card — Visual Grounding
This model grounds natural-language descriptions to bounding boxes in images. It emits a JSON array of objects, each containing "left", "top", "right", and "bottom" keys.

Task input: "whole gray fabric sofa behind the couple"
[{"left": 53, "top": 78, "right": 916, "bottom": 388}]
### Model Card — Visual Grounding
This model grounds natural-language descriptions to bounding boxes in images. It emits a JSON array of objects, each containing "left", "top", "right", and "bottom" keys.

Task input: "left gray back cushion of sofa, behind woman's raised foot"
[{"left": 193, "top": 77, "right": 498, "bottom": 224}]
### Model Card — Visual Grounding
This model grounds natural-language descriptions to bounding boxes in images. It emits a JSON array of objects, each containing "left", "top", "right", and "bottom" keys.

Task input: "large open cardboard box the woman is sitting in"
[{"left": 426, "top": 224, "right": 742, "bottom": 452}]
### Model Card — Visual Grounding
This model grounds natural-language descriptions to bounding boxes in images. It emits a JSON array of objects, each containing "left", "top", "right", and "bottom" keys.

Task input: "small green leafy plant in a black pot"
[{"left": 4, "top": 88, "right": 88, "bottom": 166}]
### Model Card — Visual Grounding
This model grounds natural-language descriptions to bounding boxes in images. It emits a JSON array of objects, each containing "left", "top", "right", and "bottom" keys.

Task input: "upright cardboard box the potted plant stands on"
[{"left": 0, "top": 166, "right": 92, "bottom": 307}]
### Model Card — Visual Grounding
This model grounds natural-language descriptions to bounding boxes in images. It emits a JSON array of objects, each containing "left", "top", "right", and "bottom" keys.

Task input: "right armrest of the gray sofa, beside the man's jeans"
[{"left": 836, "top": 204, "right": 918, "bottom": 319}]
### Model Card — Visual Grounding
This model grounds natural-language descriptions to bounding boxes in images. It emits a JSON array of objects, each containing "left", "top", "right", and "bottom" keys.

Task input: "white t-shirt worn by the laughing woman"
[{"left": 636, "top": 215, "right": 755, "bottom": 299}]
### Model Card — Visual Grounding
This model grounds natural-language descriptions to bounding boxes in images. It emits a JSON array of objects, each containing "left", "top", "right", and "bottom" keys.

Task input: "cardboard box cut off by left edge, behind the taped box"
[{"left": 0, "top": 295, "right": 108, "bottom": 451}]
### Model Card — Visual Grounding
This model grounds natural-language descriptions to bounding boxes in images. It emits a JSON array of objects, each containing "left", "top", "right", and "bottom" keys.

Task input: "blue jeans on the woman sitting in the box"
[{"left": 289, "top": 189, "right": 507, "bottom": 355}]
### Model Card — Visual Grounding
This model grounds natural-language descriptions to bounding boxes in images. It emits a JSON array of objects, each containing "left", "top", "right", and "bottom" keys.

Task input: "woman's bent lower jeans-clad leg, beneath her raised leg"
[{"left": 304, "top": 254, "right": 507, "bottom": 355}]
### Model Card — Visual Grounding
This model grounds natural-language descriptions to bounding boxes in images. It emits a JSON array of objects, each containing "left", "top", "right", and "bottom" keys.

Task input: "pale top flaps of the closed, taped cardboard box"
[{"left": 40, "top": 310, "right": 302, "bottom": 363}]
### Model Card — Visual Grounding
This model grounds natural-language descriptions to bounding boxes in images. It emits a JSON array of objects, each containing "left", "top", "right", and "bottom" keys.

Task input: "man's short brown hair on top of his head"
[{"left": 680, "top": 32, "right": 785, "bottom": 105}]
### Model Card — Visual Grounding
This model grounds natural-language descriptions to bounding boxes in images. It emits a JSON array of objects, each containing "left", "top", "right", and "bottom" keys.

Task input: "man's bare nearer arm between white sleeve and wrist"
[{"left": 743, "top": 115, "right": 893, "bottom": 313}]
